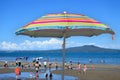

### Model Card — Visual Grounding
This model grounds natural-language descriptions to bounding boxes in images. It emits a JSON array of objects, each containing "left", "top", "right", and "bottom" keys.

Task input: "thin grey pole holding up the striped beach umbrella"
[{"left": 62, "top": 33, "right": 66, "bottom": 80}]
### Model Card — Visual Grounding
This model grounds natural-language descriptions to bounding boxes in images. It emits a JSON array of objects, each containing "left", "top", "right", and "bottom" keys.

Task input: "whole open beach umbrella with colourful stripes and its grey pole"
[{"left": 16, "top": 12, "right": 114, "bottom": 80}]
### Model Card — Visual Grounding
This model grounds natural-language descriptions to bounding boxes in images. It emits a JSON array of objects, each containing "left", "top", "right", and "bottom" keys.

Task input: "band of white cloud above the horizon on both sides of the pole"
[{"left": 0, "top": 38, "right": 120, "bottom": 50}]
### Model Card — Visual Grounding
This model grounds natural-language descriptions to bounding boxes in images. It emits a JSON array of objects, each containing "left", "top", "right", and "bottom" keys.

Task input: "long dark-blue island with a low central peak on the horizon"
[{"left": 0, "top": 45, "right": 120, "bottom": 53}]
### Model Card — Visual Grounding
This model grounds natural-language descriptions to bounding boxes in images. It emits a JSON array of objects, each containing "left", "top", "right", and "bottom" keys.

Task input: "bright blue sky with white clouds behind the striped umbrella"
[{"left": 0, "top": 0, "right": 120, "bottom": 50}]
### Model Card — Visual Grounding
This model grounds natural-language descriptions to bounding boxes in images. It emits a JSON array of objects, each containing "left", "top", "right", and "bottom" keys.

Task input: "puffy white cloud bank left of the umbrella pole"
[{"left": 0, "top": 38, "right": 62, "bottom": 50}]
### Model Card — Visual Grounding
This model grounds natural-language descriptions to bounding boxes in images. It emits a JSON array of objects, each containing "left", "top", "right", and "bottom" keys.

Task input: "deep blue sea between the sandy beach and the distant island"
[{"left": 0, "top": 51, "right": 120, "bottom": 65}]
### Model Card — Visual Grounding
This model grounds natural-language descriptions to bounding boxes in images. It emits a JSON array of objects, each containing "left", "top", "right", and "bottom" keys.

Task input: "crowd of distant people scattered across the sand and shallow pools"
[{"left": 0, "top": 58, "right": 98, "bottom": 80}]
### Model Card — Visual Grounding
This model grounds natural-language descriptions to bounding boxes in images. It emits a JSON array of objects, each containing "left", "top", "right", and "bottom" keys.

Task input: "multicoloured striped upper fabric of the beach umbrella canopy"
[{"left": 20, "top": 13, "right": 108, "bottom": 30}]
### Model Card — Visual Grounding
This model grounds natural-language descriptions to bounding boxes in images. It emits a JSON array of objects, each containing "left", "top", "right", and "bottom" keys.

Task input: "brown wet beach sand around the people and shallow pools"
[{"left": 0, "top": 62, "right": 120, "bottom": 80}]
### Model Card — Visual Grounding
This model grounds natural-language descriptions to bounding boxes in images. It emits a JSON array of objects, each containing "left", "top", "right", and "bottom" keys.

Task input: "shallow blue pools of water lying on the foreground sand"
[{"left": 0, "top": 68, "right": 77, "bottom": 80}]
